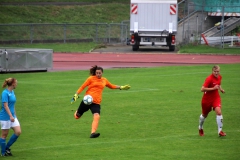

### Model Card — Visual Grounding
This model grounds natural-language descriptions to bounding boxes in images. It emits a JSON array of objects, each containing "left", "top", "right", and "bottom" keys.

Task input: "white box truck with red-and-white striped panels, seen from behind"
[{"left": 130, "top": 0, "right": 178, "bottom": 51}]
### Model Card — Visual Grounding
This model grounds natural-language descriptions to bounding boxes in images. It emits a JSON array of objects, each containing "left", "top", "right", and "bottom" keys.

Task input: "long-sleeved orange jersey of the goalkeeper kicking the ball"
[{"left": 77, "top": 76, "right": 117, "bottom": 104}]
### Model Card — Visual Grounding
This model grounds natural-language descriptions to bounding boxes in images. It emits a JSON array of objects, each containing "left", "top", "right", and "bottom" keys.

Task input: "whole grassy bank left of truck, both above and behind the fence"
[{"left": 0, "top": 2, "right": 130, "bottom": 43}]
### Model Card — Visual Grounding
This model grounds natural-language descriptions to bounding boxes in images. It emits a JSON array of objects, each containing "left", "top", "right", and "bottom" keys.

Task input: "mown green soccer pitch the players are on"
[{"left": 0, "top": 64, "right": 240, "bottom": 160}]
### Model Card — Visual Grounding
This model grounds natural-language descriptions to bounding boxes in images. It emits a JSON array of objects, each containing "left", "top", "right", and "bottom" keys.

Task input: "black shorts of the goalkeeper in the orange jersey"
[{"left": 78, "top": 101, "right": 101, "bottom": 115}]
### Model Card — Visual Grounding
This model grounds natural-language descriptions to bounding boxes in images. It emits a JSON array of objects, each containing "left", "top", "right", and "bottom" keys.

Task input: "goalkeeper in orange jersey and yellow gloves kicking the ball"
[{"left": 71, "top": 65, "right": 130, "bottom": 138}]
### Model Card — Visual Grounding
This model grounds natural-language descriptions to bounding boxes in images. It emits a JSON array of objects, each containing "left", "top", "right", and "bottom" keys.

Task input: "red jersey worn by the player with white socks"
[{"left": 202, "top": 74, "right": 222, "bottom": 101}]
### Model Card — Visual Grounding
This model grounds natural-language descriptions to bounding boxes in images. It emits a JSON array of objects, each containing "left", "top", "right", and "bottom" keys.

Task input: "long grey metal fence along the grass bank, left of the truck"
[{"left": 0, "top": 23, "right": 129, "bottom": 44}]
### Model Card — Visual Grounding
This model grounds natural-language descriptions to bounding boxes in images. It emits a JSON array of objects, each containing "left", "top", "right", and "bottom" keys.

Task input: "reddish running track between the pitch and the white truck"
[{"left": 52, "top": 53, "right": 240, "bottom": 71}]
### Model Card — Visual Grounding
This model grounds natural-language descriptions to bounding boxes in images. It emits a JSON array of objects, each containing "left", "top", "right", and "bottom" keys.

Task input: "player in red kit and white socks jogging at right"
[{"left": 199, "top": 65, "right": 226, "bottom": 137}]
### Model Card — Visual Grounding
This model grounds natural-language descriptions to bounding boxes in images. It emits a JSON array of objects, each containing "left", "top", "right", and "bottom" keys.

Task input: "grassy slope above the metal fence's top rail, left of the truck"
[{"left": 0, "top": 3, "right": 130, "bottom": 24}]
